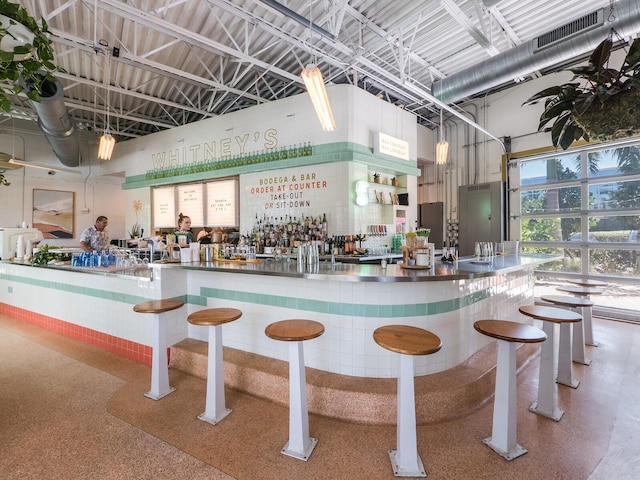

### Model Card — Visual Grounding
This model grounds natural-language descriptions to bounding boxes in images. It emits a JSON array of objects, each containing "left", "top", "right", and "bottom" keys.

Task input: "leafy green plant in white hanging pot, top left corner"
[{"left": 0, "top": 0, "right": 65, "bottom": 112}]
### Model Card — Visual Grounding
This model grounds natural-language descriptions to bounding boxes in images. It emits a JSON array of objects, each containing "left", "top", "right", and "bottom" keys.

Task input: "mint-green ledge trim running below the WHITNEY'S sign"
[{"left": 122, "top": 142, "right": 420, "bottom": 190}]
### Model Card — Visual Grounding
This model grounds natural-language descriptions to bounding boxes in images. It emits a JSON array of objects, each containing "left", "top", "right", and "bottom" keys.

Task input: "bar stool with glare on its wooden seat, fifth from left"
[{"left": 473, "top": 320, "right": 547, "bottom": 461}]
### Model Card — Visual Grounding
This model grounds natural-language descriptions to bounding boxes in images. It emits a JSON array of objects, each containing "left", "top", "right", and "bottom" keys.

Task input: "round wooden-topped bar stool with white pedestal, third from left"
[{"left": 264, "top": 319, "right": 324, "bottom": 462}]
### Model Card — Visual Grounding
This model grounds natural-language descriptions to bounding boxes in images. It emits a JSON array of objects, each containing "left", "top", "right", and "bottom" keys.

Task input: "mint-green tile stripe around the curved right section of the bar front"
[{"left": 200, "top": 287, "right": 490, "bottom": 318}]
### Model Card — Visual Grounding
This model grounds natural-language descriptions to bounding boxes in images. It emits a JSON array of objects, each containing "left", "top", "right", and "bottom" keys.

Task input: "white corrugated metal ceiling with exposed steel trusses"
[{"left": 0, "top": 0, "right": 632, "bottom": 144}]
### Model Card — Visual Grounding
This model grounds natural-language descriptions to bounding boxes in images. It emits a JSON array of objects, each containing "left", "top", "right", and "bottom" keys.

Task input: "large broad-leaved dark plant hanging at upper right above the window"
[{"left": 523, "top": 37, "right": 640, "bottom": 150}]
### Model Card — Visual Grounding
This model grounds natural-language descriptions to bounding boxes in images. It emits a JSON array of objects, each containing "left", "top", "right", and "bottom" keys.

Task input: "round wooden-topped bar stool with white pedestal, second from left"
[{"left": 187, "top": 308, "right": 242, "bottom": 425}]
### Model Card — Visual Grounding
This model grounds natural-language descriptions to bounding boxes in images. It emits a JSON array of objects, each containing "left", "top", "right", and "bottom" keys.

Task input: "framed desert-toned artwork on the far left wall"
[{"left": 33, "top": 188, "right": 74, "bottom": 238}]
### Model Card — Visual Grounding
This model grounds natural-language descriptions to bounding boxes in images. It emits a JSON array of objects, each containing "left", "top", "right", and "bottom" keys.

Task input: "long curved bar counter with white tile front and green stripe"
[{"left": 0, "top": 255, "right": 557, "bottom": 378}]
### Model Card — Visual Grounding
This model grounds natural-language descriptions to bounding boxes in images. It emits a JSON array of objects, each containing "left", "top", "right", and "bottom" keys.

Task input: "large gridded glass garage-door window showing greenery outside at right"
[{"left": 509, "top": 140, "right": 640, "bottom": 318}]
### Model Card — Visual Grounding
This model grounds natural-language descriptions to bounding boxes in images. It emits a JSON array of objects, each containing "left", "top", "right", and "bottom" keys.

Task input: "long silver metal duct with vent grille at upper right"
[{"left": 431, "top": 0, "right": 640, "bottom": 103}]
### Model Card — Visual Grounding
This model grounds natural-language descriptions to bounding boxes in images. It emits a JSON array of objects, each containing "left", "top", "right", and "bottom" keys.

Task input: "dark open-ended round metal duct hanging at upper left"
[{"left": 25, "top": 79, "right": 80, "bottom": 167}]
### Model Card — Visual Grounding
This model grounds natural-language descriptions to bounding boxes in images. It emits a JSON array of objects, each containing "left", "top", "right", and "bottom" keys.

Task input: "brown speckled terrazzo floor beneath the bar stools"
[{"left": 0, "top": 315, "right": 640, "bottom": 480}]
